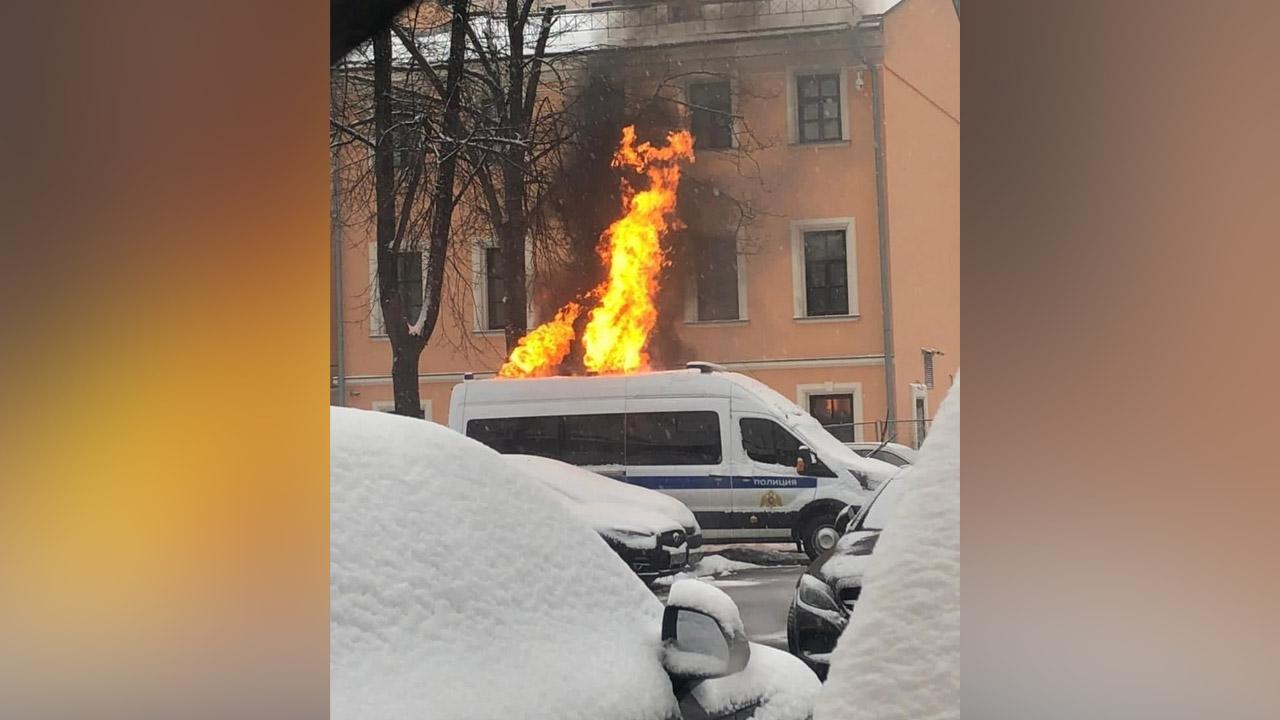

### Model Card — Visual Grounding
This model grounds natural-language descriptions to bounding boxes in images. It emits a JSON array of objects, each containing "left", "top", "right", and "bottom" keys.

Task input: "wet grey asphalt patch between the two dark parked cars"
[{"left": 654, "top": 565, "right": 805, "bottom": 650}]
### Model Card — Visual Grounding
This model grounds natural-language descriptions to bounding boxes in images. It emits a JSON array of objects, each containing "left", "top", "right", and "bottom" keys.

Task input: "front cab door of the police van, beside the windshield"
[{"left": 732, "top": 413, "right": 818, "bottom": 538}]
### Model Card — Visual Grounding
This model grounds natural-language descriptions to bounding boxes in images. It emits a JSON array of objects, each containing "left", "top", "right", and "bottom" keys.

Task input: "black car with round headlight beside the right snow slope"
[{"left": 787, "top": 473, "right": 906, "bottom": 679}]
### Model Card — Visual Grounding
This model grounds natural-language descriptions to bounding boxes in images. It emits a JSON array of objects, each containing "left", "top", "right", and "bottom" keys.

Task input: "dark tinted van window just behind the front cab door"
[{"left": 627, "top": 410, "right": 722, "bottom": 465}]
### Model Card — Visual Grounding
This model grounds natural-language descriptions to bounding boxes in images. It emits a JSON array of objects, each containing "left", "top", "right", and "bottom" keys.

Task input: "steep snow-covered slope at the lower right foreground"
[{"left": 814, "top": 377, "right": 960, "bottom": 720}]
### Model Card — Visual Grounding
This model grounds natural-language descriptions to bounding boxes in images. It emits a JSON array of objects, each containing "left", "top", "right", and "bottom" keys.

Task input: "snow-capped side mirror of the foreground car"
[{"left": 662, "top": 579, "right": 751, "bottom": 680}]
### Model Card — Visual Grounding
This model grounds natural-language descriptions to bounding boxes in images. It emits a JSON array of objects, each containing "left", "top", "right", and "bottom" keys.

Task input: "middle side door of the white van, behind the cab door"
[{"left": 623, "top": 397, "right": 733, "bottom": 538}]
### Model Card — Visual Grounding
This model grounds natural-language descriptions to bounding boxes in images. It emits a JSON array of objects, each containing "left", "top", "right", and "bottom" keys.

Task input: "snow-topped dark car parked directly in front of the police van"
[{"left": 506, "top": 455, "right": 703, "bottom": 582}]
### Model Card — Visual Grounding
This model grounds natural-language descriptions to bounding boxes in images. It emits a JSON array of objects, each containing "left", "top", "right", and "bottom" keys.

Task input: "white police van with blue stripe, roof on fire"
[{"left": 449, "top": 363, "right": 897, "bottom": 557}]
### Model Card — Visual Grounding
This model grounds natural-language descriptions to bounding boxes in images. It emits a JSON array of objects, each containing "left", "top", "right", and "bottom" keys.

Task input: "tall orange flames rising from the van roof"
[{"left": 498, "top": 126, "right": 694, "bottom": 378}]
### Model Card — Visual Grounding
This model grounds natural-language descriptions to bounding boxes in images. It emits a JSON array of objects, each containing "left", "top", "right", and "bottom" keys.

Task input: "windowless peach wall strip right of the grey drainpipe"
[{"left": 882, "top": 0, "right": 960, "bottom": 425}]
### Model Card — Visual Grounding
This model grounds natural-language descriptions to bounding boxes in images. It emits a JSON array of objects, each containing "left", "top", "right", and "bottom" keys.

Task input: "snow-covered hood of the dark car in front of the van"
[{"left": 504, "top": 455, "right": 698, "bottom": 528}]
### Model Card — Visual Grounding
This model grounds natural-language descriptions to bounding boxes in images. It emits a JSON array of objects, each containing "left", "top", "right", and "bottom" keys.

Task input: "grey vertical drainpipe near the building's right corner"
[{"left": 858, "top": 15, "right": 897, "bottom": 439}]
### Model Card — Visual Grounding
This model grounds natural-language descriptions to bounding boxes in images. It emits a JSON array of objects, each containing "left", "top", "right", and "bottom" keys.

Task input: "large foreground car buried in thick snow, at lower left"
[{"left": 329, "top": 407, "right": 820, "bottom": 720}]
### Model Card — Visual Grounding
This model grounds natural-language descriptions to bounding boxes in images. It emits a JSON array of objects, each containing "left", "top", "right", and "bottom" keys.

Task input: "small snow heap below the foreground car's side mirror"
[{"left": 692, "top": 643, "right": 822, "bottom": 720}]
